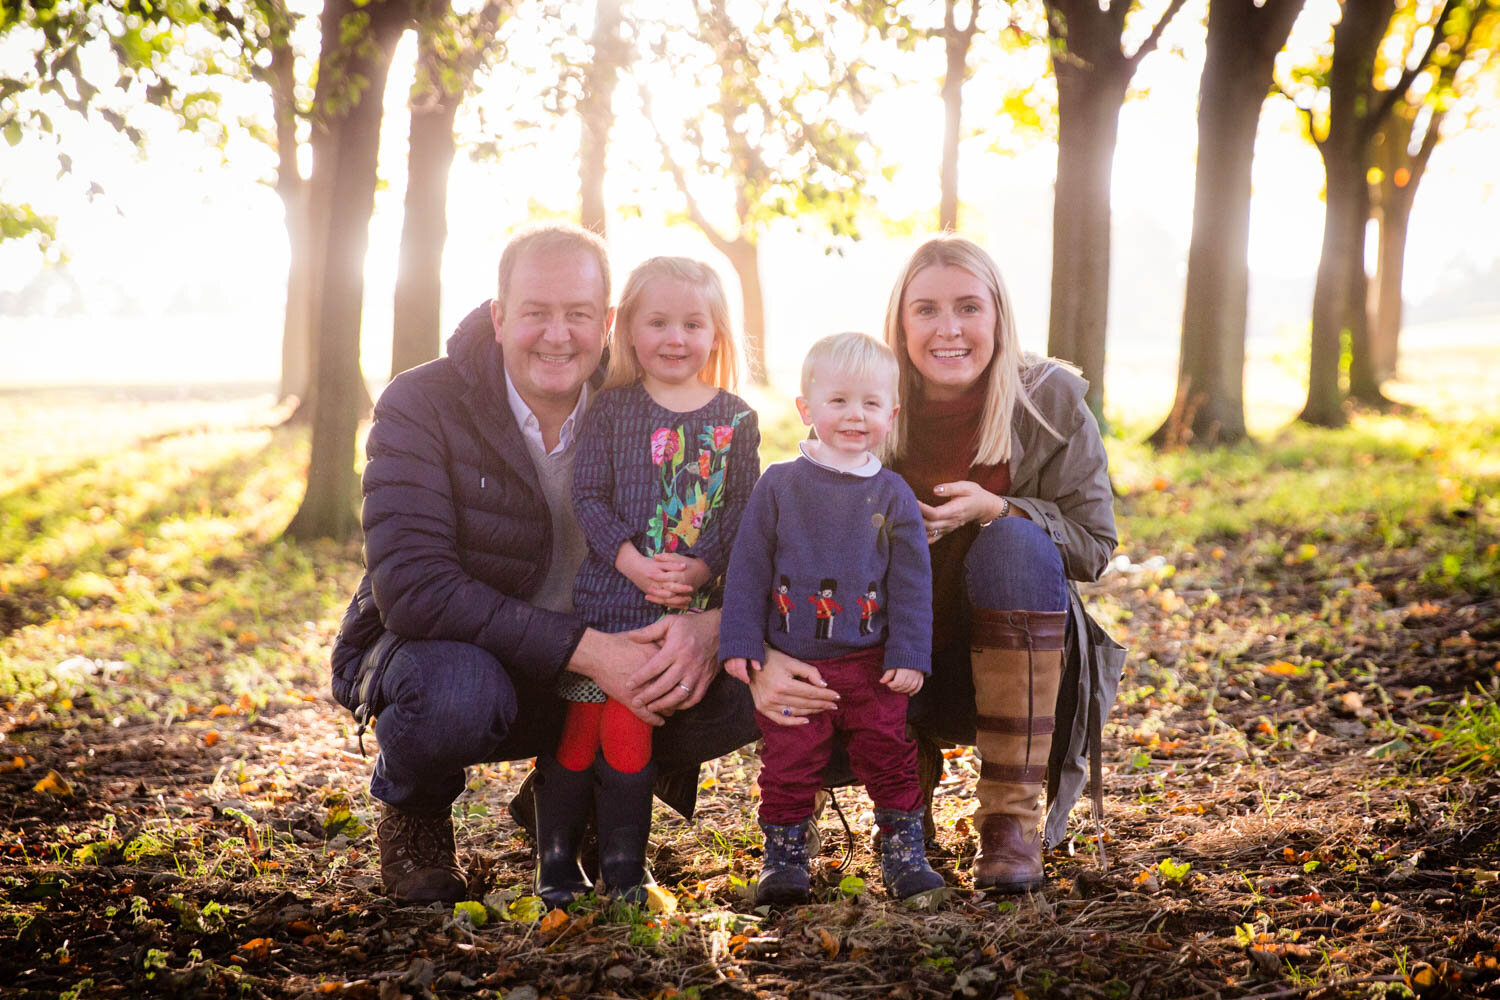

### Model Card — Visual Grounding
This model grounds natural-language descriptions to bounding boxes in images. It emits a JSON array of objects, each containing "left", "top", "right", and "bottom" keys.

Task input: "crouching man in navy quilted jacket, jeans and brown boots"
[{"left": 333, "top": 226, "right": 756, "bottom": 903}]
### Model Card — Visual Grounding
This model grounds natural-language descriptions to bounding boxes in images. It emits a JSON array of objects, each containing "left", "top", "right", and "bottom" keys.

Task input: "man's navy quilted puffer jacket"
[{"left": 333, "top": 303, "right": 584, "bottom": 709}]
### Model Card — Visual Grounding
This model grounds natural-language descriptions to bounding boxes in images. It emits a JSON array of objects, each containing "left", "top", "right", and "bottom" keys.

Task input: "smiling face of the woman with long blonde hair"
[{"left": 902, "top": 264, "right": 996, "bottom": 402}]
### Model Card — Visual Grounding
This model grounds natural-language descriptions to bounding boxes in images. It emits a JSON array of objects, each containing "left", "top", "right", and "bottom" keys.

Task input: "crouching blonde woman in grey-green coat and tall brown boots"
[{"left": 752, "top": 235, "right": 1125, "bottom": 892}]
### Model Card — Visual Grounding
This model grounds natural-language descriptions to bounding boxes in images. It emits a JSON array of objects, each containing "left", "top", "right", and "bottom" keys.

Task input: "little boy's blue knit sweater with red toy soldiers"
[{"left": 719, "top": 456, "right": 933, "bottom": 673}]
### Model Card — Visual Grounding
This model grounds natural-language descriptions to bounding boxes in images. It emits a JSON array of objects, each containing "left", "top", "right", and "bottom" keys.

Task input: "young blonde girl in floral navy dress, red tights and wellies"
[{"left": 537, "top": 256, "right": 761, "bottom": 907}]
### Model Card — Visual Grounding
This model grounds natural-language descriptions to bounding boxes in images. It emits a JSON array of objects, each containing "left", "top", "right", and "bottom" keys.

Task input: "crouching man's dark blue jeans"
[{"left": 371, "top": 639, "right": 759, "bottom": 814}]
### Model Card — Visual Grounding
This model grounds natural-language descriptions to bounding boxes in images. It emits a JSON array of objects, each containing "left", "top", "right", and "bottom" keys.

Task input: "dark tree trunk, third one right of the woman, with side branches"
[{"left": 1298, "top": 0, "right": 1395, "bottom": 427}]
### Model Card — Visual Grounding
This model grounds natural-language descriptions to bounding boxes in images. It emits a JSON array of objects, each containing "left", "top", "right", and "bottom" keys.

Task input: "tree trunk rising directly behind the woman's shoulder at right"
[{"left": 1047, "top": 60, "right": 1130, "bottom": 418}]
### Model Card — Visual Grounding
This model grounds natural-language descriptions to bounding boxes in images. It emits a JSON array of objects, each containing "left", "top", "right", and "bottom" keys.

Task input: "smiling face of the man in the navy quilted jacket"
[{"left": 489, "top": 250, "right": 615, "bottom": 409}]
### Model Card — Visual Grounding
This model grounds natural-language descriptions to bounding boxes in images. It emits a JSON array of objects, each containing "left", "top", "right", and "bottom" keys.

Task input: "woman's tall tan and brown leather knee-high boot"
[{"left": 969, "top": 609, "right": 1068, "bottom": 892}]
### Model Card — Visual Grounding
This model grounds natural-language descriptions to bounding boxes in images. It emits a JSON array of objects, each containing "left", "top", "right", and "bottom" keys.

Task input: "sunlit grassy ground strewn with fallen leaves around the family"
[{"left": 0, "top": 386, "right": 1500, "bottom": 999}]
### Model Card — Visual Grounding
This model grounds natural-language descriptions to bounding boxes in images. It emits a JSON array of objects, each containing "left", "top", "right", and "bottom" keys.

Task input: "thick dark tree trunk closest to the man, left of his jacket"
[{"left": 287, "top": 0, "right": 405, "bottom": 541}]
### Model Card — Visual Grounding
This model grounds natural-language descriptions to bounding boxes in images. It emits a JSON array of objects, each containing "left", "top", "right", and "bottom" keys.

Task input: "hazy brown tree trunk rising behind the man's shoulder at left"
[{"left": 390, "top": 17, "right": 464, "bottom": 378}]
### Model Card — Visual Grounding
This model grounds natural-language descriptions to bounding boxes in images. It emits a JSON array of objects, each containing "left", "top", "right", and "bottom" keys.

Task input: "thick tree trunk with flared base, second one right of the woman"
[{"left": 1151, "top": 0, "right": 1304, "bottom": 447}]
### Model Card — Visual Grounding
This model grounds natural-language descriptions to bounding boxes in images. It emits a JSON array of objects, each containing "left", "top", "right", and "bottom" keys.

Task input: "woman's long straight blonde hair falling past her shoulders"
[{"left": 885, "top": 232, "right": 1061, "bottom": 465}]
